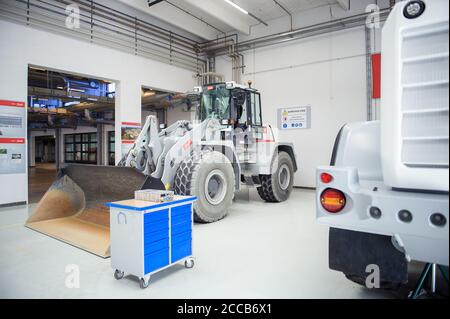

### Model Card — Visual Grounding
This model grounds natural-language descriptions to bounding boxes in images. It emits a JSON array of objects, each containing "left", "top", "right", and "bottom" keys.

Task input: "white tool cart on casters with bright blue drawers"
[{"left": 108, "top": 196, "right": 197, "bottom": 289}]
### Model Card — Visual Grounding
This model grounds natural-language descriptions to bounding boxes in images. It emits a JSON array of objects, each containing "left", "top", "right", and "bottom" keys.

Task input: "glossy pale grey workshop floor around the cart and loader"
[{"left": 0, "top": 189, "right": 442, "bottom": 299}]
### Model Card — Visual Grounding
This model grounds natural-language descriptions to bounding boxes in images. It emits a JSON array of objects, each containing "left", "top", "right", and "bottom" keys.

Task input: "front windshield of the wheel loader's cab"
[{"left": 200, "top": 84, "right": 230, "bottom": 121}]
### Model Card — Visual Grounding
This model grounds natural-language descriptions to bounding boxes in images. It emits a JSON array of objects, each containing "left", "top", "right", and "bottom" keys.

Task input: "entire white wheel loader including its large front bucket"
[{"left": 26, "top": 82, "right": 297, "bottom": 257}]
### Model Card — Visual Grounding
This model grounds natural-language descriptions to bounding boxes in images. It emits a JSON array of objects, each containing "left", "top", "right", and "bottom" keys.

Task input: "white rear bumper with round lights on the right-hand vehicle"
[{"left": 316, "top": 167, "right": 449, "bottom": 265}]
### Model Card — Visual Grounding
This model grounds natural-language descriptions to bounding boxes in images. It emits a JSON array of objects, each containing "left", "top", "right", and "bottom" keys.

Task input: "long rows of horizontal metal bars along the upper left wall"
[{"left": 0, "top": 0, "right": 206, "bottom": 72}]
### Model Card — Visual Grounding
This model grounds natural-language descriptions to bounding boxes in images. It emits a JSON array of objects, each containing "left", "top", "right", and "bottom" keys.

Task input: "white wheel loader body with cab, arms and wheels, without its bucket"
[{"left": 119, "top": 82, "right": 297, "bottom": 223}]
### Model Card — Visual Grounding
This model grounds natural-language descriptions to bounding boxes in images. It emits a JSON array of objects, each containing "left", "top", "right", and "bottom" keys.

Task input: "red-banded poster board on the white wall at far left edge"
[{"left": 0, "top": 100, "right": 27, "bottom": 174}]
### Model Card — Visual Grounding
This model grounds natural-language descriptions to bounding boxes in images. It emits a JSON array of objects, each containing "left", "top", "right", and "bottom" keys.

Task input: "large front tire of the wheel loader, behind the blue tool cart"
[{"left": 174, "top": 150, "right": 235, "bottom": 223}]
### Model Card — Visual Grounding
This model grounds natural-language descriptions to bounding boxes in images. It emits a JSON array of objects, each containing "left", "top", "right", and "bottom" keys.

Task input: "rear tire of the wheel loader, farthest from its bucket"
[{"left": 257, "top": 152, "right": 294, "bottom": 203}]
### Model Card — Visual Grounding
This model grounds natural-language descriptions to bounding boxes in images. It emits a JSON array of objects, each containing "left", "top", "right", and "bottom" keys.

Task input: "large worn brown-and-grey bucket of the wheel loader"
[{"left": 25, "top": 165, "right": 163, "bottom": 258}]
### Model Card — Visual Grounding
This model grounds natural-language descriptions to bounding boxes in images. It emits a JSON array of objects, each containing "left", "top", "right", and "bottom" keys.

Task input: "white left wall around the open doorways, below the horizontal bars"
[{"left": 0, "top": 20, "right": 195, "bottom": 205}]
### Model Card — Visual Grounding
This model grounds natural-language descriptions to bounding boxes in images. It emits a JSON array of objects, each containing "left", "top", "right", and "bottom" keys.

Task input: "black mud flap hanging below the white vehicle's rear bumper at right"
[{"left": 329, "top": 228, "right": 408, "bottom": 284}]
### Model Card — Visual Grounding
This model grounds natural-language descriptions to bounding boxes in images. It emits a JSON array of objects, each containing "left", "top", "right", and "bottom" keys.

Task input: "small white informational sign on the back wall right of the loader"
[{"left": 278, "top": 106, "right": 311, "bottom": 130}]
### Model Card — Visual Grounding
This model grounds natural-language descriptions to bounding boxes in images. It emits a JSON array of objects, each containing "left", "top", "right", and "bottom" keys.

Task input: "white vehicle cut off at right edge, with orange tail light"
[{"left": 317, "top": 0, "right": 449, "bottom": 287}]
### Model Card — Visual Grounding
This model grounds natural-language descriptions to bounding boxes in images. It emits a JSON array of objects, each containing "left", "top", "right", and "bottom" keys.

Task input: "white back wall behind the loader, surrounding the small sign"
[{"left": 216, "top": 28, "right": 367, "bottom": 187}]
